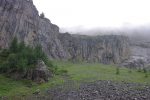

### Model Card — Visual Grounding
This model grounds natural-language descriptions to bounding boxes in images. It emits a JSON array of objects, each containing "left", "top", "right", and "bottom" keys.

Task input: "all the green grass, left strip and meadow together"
[{"left": 0, "top": 61, "right": 150, "bottom": 97}]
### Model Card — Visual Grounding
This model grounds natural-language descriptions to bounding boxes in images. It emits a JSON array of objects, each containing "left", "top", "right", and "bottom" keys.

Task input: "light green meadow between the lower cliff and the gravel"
[{"left": 55, "top": 62, "right": 150, "bottom": 84}]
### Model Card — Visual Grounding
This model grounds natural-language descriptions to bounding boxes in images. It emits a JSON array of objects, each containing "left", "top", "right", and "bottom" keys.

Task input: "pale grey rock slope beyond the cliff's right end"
[{"left": 121, "top": 39, "right": 150, "bottom": 70}]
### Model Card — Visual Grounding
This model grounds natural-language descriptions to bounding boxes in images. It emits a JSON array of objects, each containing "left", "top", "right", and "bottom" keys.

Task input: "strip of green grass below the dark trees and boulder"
[{"left": 0, "top": 75, "right": 63, "bottom": 98}]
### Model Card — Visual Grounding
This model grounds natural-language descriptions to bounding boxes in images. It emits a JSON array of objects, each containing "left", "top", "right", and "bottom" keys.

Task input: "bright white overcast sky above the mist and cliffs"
[{"left": 33, "top": 0, "right": 150, "bottom": 28}]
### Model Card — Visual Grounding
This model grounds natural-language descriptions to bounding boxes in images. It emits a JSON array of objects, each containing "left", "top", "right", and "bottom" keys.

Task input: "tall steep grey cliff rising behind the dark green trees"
[{"left": 0, "top": 0, "right": 65, "bottom": 58}]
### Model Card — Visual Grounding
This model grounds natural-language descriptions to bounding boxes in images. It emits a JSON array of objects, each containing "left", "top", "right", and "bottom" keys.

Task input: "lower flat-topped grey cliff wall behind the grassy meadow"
[{"left": 59, "top": 33, "right": 130, "bottom": 64}]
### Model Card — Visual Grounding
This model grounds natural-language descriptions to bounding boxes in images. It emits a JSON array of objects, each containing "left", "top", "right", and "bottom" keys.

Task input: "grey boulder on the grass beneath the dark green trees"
[{"left": 8, "top": 60, "right": 52, "bottom": 83}]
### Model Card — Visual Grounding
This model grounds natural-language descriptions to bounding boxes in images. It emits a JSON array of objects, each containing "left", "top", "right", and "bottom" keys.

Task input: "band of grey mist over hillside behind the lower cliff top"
[{"left": 60, "top": 25, "right": 150, "bottom": 41}]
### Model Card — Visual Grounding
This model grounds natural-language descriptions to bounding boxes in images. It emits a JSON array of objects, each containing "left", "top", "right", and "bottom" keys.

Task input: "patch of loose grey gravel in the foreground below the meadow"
[{"left": 47, "top": 81, "right": 150, "bottom": 100}]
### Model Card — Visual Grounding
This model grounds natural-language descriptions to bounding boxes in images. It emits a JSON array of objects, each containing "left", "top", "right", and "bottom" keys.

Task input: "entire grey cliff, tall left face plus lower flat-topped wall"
[{"left": 0, "top": 0, "right": 129, "bottom": 63}]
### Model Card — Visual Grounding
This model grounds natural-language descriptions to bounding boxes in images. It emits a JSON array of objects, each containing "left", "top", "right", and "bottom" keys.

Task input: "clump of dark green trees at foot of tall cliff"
[{"left": 0, "top": 38, "right": 52, "bottom": 73}]
